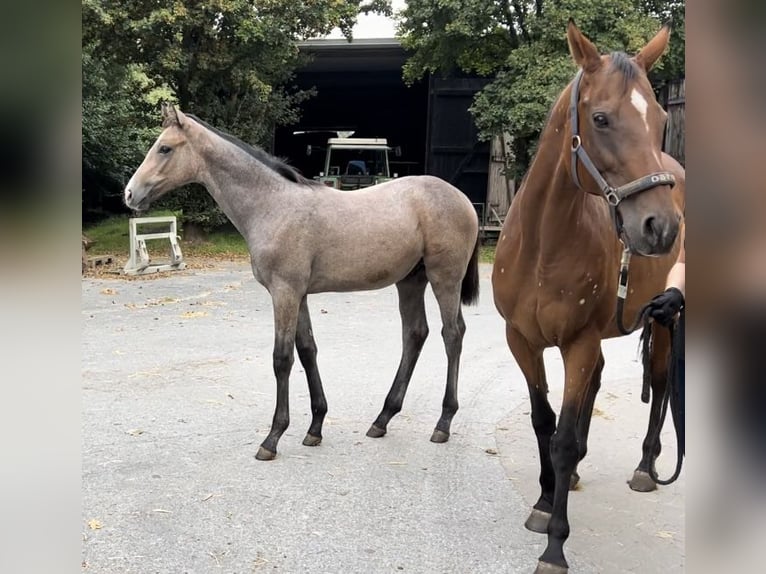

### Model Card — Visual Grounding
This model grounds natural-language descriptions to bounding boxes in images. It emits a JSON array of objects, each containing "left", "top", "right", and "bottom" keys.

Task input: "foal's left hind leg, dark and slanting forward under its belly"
[{"left": 367, "top": 267, "right": 428, "bottom": 438}]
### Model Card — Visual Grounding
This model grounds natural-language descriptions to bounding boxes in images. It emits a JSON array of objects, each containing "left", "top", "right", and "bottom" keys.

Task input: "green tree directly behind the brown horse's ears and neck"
[{"left": 398, "top": 0, "right": 683, "bottom": 178}]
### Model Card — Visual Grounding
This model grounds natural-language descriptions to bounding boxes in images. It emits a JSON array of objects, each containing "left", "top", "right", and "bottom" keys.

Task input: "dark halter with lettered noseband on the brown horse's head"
[{"left": 569, "top": 68, "right": 676, "bottom": 212}]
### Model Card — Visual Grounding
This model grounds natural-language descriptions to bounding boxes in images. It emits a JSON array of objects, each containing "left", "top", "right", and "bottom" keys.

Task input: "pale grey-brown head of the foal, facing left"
[{"left": 125, "top": 103, "right": 197, "bottom": 211}]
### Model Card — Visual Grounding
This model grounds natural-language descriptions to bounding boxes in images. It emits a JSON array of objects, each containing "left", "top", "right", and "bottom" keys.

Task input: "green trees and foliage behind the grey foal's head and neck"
[{"left": 82, "top": 0, "right": 390, "bottom": 227}]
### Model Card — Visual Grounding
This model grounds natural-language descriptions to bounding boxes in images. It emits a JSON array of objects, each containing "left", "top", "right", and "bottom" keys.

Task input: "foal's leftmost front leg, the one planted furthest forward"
[{"left": 255, "top": 286, "right": 301, "bottom": 460}]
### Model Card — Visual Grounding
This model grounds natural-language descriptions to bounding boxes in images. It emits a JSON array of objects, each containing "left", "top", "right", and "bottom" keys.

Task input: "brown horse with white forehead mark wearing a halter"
[{"left": 492, "top": 19, "right": 685, "bottom": 574}]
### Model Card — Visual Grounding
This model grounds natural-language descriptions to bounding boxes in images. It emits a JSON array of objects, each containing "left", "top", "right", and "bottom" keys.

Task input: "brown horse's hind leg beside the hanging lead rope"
[{"left": 628, "top": 323, "right": 670, "bottom": 492}]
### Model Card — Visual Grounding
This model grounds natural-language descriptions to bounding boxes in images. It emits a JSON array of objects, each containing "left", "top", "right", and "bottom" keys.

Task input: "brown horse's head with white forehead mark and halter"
[{"left": 567, "top": 19, "right": 681, "bottom": 255}]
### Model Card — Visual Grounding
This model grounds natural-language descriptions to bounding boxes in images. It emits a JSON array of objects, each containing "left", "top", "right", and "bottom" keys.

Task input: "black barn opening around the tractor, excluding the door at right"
[{"left": 274, "top": 39, "right": 428, "bottom": 182}]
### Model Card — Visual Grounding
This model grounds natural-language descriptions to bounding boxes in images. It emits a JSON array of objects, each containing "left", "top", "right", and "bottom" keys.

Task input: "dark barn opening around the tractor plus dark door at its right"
[{"left": 274, "top": 39, "right": 490, "bottom": 209}]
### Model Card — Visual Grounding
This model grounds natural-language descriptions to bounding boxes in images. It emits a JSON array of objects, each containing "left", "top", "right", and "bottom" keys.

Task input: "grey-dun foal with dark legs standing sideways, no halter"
[{"left": 124, "top": 104, "right": 479, "bottom": 460}]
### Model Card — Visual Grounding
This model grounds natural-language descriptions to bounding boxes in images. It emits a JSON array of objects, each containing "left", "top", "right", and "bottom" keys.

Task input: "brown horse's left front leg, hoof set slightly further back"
[{"left": 505, "top": 323, "right": 556, "bottom": 534}]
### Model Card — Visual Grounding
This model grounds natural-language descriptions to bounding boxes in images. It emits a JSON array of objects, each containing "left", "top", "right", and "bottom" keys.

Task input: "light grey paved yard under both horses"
[{"left": 82, "top": 263, "right": 685, "bottom": 574}]
